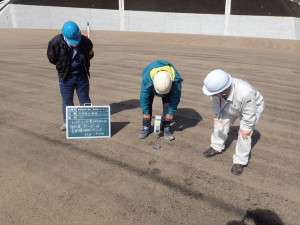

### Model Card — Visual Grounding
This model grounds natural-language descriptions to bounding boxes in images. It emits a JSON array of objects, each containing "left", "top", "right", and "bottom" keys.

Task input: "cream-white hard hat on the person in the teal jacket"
[{"left": 153, "top": 71, "right": 172, "bottom": 94}]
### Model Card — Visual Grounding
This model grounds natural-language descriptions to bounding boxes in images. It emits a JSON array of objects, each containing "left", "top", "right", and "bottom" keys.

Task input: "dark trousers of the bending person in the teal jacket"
[{"left": 143, "top": 93, "right": 171, "bottom": 129}]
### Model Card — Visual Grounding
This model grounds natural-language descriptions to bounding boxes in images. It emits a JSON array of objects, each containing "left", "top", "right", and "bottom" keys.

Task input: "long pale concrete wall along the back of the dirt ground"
[{"left": 0, "top": 4, "right": 300, "bottom": 39}]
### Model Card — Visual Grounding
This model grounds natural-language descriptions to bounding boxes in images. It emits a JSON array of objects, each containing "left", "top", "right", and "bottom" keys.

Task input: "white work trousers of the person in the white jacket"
[{"left": 210, "top": 110, "right": 262, "bottom": 165}]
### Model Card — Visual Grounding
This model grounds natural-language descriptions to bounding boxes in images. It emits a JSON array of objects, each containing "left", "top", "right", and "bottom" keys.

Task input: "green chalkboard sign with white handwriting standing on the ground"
[{"left": 66, "top": 106, "right": 111, "bottom": 139}]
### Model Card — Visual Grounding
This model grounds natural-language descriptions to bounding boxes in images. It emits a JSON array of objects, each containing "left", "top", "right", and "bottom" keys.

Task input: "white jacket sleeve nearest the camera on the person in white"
[{"left": 240, "top": 92, "right": 256, "bottom": 131}]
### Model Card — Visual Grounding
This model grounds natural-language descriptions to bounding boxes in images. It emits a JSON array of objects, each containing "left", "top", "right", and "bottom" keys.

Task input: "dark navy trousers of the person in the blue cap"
[{"left": 59, "top": 75, "right": 91, "bottom": 123}]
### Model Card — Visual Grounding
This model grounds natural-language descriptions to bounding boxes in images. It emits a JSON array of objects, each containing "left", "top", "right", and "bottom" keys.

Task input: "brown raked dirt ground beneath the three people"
[{"left": 0, "top": 29, "right": 300, "bottom": 225}]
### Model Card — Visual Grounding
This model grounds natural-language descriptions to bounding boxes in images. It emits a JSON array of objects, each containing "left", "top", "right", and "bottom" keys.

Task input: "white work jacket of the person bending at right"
[{"left": 211, "top": 78, "right": 264, "bottom": 131}]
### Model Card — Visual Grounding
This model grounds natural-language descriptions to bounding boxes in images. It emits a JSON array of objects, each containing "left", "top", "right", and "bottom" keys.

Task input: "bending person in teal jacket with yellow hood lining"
[{"left": 139, "top": 60, "right": 183, "bottom": 141}]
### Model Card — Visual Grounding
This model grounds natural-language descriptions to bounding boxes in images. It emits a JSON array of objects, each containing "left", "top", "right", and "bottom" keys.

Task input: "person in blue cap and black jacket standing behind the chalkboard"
[{"left": 47, "top": 21, "right": 94, "bottom": 131}]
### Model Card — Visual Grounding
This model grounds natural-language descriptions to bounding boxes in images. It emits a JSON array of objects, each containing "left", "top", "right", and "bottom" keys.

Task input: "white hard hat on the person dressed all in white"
[{"left": 202, "top": 69, "right": 232, "bottom": 96}]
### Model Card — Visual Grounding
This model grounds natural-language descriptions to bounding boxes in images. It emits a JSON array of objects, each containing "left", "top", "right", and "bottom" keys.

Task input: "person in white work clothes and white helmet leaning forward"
[{"left": 202, "top": 69, "right": 264, "bottom": 175}]
